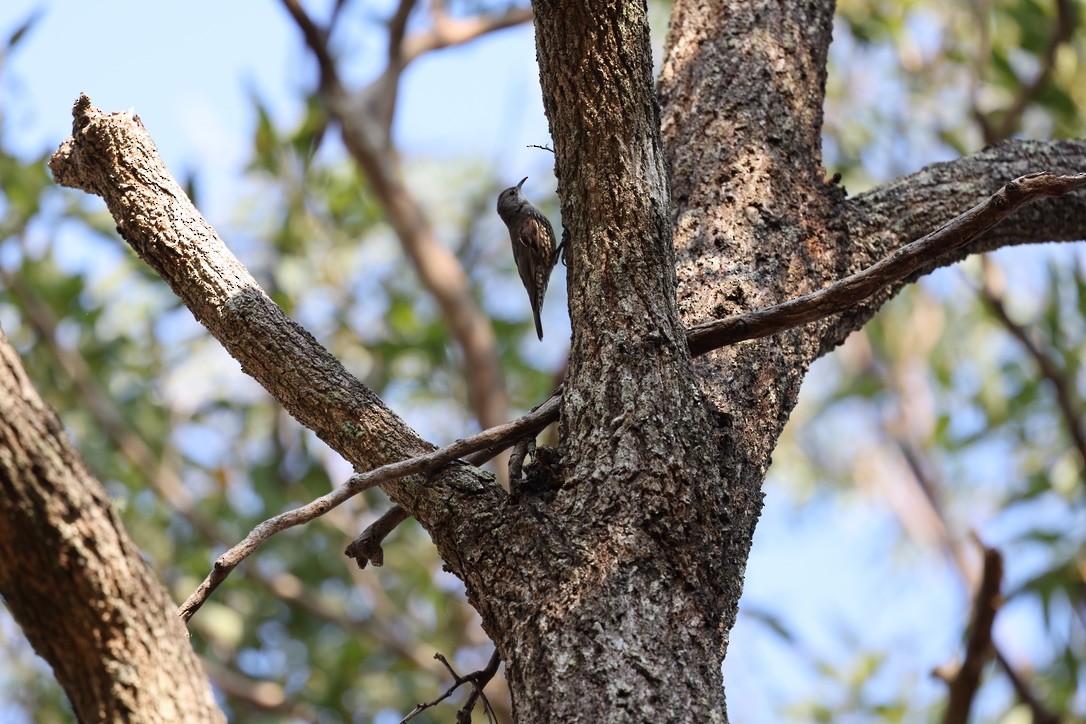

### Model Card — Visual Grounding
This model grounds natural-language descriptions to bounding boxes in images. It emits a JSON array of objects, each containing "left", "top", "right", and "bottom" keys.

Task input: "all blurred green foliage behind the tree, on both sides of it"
[{"left": 0, "top": 0, "right": 1086, "bottom": 722}]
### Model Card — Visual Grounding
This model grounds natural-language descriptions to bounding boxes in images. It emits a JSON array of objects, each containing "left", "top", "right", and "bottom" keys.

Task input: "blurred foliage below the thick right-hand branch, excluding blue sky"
[{"left": 778, "top": 255, "right": 1086, "bottom": 721}]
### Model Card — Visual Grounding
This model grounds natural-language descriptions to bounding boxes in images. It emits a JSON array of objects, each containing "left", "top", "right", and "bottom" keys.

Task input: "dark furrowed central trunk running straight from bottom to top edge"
[{"left": 508, "top": 0, "right": 728, "bottom": 722}]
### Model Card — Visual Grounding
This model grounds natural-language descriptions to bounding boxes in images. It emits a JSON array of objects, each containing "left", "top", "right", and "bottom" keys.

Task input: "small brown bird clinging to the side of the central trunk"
[{"left": 497, "top": 176, "right": 558, "bottom": 340}]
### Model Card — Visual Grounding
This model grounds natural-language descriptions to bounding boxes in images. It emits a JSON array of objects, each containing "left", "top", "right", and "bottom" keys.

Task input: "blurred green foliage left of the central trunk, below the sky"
[{"left": 0, "top": 5, "right": 554, "bottom": 722}]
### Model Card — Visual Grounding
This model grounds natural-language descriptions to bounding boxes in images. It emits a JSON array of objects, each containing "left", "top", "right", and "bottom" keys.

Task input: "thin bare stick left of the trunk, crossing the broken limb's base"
[{"left": 178, "top": 396, "right": 561, "bottom": 621}]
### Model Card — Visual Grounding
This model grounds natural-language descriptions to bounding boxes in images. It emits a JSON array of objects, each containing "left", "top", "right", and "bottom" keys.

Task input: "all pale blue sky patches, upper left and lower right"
[{"left": 0, "top": 0, "right": 1072, "bottom": 722}]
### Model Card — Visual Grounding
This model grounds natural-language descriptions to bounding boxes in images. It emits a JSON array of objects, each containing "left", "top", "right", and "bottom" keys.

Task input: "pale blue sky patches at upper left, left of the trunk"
[{"left": 0, "top": 0, "right": 543, "bottom": 215}]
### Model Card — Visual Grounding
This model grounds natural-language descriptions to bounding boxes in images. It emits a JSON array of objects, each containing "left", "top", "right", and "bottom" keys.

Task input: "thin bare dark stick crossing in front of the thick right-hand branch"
[{"left": 686, "top": 173, "right": 1086, "bottom": 357}]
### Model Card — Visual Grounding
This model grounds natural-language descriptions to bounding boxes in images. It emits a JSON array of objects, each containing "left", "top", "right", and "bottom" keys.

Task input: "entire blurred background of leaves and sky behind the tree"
[{"left": 0, "top": 0, "right": 1086, "bottom": 723}]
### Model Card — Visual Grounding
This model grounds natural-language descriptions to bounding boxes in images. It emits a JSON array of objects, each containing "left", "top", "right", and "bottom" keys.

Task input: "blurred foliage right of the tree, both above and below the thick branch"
[{"left": 774, "top": 0, "right": 1086, "bottom": 722}]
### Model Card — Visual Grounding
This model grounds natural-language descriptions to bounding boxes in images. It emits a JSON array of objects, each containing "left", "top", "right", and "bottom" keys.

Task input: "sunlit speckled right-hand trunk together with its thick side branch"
[{"left": 659, "top": 0, "right": 1086, "bottom": 716}]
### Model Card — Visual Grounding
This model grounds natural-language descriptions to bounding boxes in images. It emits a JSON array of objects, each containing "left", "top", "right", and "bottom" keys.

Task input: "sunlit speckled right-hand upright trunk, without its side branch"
[{"left": 659, "top": 0, "right": 844, "bottom": 681}]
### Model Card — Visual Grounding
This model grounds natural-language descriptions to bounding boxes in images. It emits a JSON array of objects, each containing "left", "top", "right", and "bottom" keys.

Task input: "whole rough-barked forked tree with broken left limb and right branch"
[{"left": 31, "top": 0, "right": 1083, "bottom": 722}]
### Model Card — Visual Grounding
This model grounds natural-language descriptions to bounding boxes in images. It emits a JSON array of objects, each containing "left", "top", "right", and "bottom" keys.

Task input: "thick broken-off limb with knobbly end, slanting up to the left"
[{"left": 50, "top": 96, "right": 504, "bottom": 564}]
